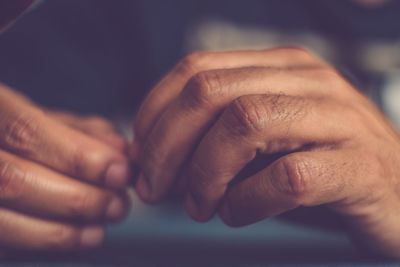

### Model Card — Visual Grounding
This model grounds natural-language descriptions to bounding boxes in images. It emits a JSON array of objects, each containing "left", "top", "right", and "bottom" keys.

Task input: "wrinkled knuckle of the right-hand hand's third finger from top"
[{"left": 224, "top": 96, "right": 271, "bottom": 135}]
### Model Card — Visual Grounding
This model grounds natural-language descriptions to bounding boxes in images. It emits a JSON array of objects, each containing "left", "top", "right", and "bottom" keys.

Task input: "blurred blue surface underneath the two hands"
[{"left": 2, "top": 194, "right": 400, "bottom": 266}]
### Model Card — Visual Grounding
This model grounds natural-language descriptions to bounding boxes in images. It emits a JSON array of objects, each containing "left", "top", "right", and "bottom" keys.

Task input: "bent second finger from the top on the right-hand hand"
[{"left": 137, "top": 68, "right": 339, "bottom": 202}]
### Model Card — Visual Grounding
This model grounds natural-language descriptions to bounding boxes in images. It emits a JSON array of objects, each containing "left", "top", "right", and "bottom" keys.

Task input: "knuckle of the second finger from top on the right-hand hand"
[{"left": 183, "top": 71, "right": 223, "bottom": 107}]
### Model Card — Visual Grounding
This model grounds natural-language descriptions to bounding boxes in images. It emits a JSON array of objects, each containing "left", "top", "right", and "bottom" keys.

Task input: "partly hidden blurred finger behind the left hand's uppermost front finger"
[{"left": 46, "top": 111, "right": 128, "bottom": 153}]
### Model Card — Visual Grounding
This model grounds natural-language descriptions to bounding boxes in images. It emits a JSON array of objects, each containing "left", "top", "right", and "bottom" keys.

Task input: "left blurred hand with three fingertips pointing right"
[{"left": 0, "top": 85, "right": 130, "bottom": 255}]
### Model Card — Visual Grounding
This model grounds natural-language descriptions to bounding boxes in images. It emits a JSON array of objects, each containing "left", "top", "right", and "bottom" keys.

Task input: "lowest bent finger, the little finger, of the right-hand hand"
[{"left": 219, "top": 150, "right": 367, "bottom": 226}]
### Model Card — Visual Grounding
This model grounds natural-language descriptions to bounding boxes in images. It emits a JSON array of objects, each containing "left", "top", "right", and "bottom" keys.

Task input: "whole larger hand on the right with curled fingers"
[{"left": 133, "top": 48, "right": 400, "bottom": 257}]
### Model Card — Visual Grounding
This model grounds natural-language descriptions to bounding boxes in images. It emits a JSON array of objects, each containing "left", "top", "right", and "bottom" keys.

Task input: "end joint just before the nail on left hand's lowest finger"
[{"left": 45, "top": 225, "right": 80, "bottom": 251}]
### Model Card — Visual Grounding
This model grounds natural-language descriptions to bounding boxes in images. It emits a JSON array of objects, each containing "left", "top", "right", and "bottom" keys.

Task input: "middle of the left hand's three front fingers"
[{"left": 0, "top": 151, "right": 127, "bottom": 221}]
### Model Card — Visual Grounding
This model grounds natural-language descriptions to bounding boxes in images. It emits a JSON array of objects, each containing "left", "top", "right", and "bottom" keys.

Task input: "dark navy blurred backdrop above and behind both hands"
[{"left": 0, "top": 0, "right": 400, "bottom": 116}]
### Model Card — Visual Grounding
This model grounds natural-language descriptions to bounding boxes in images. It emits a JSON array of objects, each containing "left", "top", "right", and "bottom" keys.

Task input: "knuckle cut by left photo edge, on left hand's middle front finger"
[{"left": 0, "top": 161, "right": 26, "bottom": 202}]
